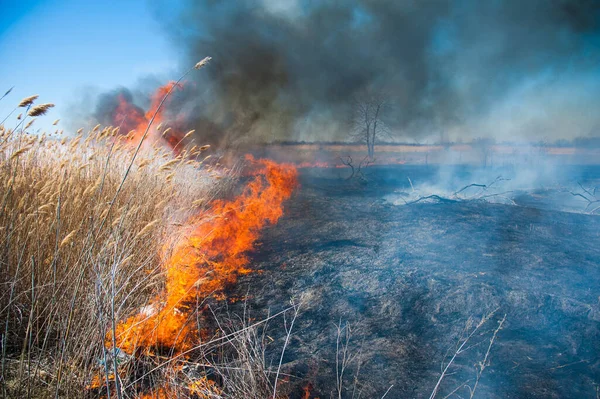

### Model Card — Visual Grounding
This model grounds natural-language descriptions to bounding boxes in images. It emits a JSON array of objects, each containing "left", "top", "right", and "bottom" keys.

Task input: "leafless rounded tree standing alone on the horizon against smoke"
[{"left": 351, "top": 89, "right": 389, "bottom": 161}]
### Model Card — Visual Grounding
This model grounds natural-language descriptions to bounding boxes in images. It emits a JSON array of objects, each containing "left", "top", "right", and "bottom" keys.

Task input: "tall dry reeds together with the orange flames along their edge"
[{"left": 0, "top": 91, "right": 296, "bottom": 398}]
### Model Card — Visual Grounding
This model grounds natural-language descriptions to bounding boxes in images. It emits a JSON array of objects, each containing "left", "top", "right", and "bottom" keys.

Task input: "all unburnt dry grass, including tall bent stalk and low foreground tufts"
[{"left": 0, "top": 65, "right": 293, "bottom": 399}]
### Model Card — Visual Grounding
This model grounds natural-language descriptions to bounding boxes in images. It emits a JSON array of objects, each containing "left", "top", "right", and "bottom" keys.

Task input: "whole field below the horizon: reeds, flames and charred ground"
[{"left": 0, "top": 123, "right": 600, "bottom": 398}]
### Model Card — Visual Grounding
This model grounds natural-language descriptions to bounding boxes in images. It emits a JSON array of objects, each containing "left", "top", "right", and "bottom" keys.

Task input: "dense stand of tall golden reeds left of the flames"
[{"left": 0, "top": 120, "right": 227, "bottom": 397}]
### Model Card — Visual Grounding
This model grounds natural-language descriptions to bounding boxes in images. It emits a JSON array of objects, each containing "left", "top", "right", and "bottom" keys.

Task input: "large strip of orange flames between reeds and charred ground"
[{"left": 109, "top": 156, "right": 297, "bottom": 354}]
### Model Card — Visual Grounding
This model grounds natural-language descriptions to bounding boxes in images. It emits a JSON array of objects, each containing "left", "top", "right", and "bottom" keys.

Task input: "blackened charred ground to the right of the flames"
[{"left": 220, "top": 166, "right": 600, "bottom": 399}]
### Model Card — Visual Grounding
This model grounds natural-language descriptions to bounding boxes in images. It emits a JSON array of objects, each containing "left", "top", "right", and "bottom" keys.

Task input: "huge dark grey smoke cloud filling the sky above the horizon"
[{"left": 138, "top": 0, "right": 600, "bottom": 144}]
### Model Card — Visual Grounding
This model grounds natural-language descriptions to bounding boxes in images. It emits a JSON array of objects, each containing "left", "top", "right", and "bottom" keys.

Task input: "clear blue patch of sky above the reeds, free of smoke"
[{"left": 0, "top": 0, "right": 180, "bottom": 131}]
